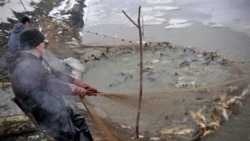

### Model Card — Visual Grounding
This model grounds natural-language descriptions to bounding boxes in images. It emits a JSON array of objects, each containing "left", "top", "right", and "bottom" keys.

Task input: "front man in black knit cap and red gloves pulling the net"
[{"left": 9, "top": 28, "right": 98, "bottom": 141}]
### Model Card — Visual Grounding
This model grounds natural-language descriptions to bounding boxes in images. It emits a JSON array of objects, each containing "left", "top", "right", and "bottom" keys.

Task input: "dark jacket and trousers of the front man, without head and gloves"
[{"left": 8, "top": 52, "right": 89, "bottom": 141}]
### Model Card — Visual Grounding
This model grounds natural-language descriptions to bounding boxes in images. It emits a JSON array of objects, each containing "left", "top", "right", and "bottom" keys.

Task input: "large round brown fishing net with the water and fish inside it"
[{"left": 72, "top": 42, "right": 249, "bottom": 141}]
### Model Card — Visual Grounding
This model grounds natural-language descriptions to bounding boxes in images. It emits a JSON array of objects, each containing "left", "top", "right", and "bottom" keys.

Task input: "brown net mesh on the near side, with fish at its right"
[{"left": 79, "top": 44, "right": 249, "bottom": 141}]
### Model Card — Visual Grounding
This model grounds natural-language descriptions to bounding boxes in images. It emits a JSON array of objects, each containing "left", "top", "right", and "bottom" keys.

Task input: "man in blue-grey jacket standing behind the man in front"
[{"left": 8, "top": 16, "right": 31, "bottom": 54}]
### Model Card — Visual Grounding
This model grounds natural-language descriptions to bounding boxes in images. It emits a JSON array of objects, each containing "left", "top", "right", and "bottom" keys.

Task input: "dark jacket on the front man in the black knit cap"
[{"left": 8, "top": 52, "right": 74, "bottom": 97}]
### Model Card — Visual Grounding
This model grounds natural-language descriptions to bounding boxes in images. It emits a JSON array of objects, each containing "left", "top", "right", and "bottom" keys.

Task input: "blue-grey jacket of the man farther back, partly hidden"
[{"left": 8, "top": 22, "right": 26, "bottom": 54}]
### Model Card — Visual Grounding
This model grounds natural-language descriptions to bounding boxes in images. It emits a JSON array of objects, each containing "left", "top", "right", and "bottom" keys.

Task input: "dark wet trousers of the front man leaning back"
[{"left": 13, "top": 90, "right": 93, "bottom": 141}]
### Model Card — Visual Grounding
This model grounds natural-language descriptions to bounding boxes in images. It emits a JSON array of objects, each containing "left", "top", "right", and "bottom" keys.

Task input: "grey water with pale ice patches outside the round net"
[{"left": 83, "top": 0, "right": 250, "bottom": 141}]
